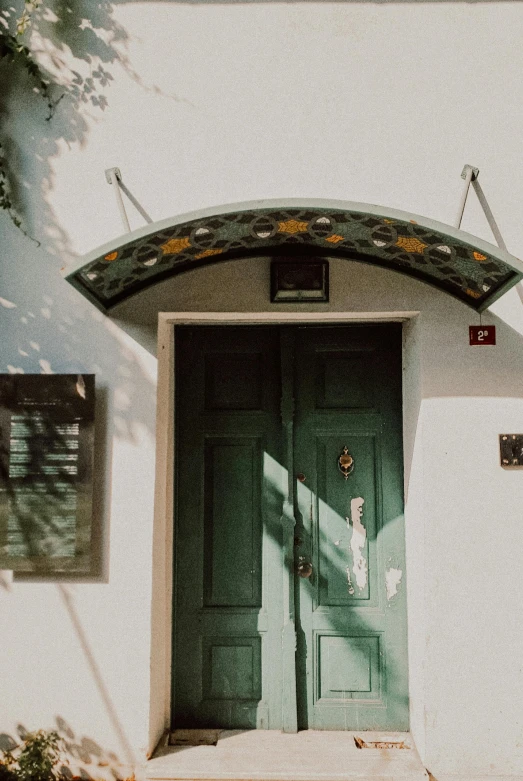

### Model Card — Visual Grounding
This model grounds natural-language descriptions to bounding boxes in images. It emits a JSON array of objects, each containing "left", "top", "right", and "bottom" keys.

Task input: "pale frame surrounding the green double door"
[{"left": 148, "top": 310, "right": 425, "bottom": 753}]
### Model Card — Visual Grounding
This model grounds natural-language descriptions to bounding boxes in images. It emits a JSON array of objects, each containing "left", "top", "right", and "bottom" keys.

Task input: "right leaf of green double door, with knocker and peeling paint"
[{"left": 294, "top": 326, "right": 408, "bottom": 730}]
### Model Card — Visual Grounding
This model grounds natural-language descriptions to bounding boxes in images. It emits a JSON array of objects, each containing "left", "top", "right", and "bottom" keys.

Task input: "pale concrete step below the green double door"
[{"left": 145, "top": 730, "right": 428, "bottom": 781}]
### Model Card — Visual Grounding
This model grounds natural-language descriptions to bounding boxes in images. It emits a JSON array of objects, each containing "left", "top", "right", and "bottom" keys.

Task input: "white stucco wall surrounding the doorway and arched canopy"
[{"left": 0, "top": 2, "right": 523, "bottom": 781}]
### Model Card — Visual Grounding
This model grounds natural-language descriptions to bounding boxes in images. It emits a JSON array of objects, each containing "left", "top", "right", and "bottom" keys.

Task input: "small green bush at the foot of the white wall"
[{"left": 0, "top": 730, "right": 60, "bottom": 781}]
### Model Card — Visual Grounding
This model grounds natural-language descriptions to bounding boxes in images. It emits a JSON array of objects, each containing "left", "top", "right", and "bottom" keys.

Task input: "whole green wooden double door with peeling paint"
[{"left": 173, "top": 326, "right": 408, "bottom": 732}]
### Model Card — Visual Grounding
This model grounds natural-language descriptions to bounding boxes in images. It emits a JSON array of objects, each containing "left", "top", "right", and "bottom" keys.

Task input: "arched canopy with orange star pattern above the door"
[{"left": 67, "top": 200, "right": 523, "bottom": 312}]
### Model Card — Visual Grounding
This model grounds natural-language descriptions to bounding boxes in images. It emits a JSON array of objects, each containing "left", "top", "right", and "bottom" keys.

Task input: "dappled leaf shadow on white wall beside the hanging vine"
[{"left": 0, "top": 0, "right": 182, "bottom": 260}]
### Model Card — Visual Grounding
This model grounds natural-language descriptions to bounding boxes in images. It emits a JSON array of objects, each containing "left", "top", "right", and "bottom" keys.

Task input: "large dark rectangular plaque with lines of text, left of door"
[{"left": 0, "top": 374, "right": 94, "bottom": 575}]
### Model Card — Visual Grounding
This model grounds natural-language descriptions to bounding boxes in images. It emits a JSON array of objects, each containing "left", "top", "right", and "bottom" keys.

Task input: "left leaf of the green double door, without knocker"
[{"left": 173, "top": 328, "right": 283, "bottom": 729}]
